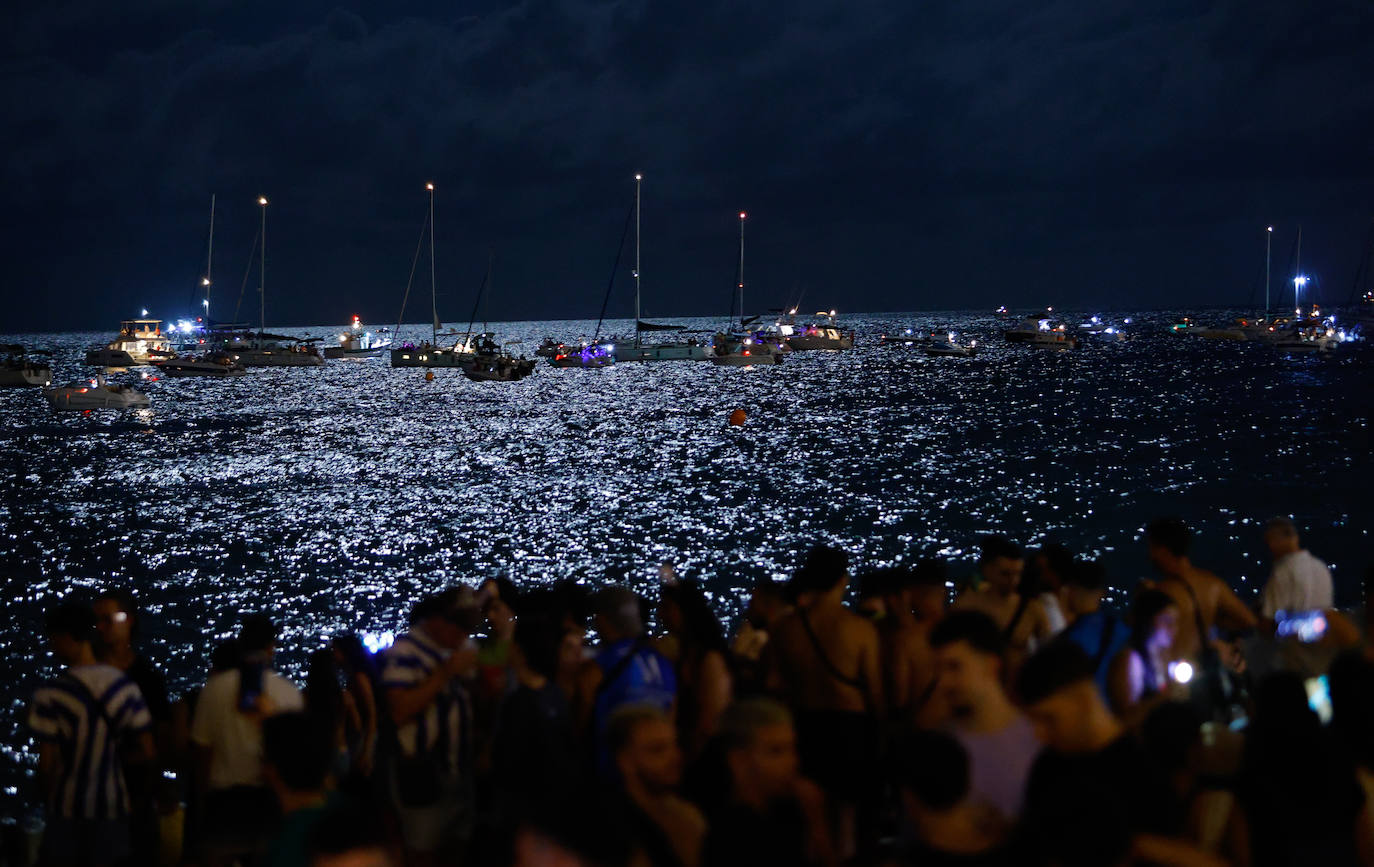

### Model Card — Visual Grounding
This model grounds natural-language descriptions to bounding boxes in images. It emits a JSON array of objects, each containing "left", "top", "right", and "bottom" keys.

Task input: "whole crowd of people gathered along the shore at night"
[{"left": 27, "top": 518, "right": 1374, "bottom": 867}]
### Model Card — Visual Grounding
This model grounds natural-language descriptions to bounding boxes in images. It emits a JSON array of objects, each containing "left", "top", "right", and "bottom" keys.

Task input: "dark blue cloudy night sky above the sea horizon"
[{"left": 0, "top": 0, "right": 1374, "bottom": 331}]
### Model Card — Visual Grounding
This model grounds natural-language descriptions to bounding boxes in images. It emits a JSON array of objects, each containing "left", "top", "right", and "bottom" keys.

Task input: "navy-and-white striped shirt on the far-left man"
[{"left": 29, "top": 665, "right": 153, "bottom": 819}]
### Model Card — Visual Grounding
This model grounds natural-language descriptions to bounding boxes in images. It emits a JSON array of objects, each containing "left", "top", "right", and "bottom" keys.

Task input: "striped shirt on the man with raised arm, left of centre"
[{"left": 382, "top": 628, "right": 473, "bottom": 779}]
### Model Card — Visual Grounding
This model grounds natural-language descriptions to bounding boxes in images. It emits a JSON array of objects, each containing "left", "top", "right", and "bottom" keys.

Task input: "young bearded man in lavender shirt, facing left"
[{"left": 930, "top": 611, "right": 1040, "bottom": 822}]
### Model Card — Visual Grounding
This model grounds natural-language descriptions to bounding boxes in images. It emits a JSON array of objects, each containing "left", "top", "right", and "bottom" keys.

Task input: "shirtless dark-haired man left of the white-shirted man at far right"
[{"left": 1145, "top": 518, "right": 1256, "bottom": 660}]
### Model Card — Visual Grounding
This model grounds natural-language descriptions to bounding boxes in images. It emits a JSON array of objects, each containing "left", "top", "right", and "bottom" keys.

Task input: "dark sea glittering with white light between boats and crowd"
[{"left": 0, "top": 312, "right": 1374, "bottom": 807}]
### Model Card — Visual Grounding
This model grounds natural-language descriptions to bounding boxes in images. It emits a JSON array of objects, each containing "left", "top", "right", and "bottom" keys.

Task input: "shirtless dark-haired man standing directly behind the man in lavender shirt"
[{"left": 954, "top": 536, "right": 1054, "bottom": 683}]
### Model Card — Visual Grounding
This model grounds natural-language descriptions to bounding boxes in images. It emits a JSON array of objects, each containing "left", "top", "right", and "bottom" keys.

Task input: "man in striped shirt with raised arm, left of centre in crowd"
[{"left": 381, "top": 585, "right": 482, "bottom": 866}]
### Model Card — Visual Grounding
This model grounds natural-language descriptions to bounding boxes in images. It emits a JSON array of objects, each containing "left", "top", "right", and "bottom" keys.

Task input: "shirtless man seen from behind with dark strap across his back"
[{"left": 768, "top": 547, "right": 885, "bottom": 844}]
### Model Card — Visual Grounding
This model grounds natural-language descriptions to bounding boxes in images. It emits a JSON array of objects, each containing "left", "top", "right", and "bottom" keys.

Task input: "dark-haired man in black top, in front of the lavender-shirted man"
[{"left": 1017, "top": 642, "right": 1187, "bottom": 867}]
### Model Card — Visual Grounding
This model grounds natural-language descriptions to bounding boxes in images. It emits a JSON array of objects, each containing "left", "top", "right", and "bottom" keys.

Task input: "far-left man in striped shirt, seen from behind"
[{"left": 27, "top": 599, "right": 154, "bottom": 867}]
